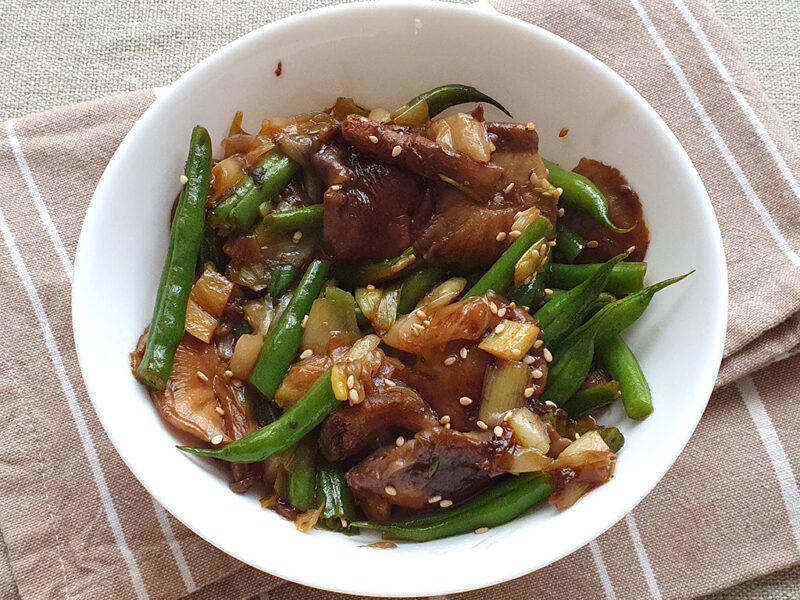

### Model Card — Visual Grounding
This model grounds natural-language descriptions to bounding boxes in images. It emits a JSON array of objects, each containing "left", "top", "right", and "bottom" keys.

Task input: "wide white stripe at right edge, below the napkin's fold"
[{"left": 736, "top": 376, "right": 800, "bottom": 549}]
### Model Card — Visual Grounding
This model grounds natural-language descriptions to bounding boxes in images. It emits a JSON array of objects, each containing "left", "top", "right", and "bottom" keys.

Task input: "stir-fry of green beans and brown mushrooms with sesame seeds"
[{"left": 131, "top": 85, "right": 685, "bottom": 541}]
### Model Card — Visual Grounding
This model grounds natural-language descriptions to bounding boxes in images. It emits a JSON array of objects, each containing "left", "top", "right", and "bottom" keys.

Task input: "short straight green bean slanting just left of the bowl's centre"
[{"left": 250, "top": 260, "right": 329, "bottom": 400}]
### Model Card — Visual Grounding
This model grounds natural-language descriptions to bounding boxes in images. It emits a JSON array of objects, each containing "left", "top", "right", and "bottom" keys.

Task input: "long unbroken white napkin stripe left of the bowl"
[{"left": 0, "top": 209, "right": 149, "bottom": 600}]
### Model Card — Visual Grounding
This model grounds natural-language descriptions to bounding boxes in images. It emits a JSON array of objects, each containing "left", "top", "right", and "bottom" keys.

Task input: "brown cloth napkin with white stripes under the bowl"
[{"left": 0, "top": 0, "right": 800, "bottom": 600}]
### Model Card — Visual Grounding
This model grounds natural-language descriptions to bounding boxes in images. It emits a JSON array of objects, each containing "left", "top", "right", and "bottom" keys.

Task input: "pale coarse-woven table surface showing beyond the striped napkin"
[{"left": 0, "top": 0, "right": 800, "bottom": 600}]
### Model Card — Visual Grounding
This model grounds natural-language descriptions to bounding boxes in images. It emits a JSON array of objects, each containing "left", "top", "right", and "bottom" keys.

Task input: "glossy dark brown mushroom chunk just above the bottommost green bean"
[{"left": 345, "top": 427, "right": 491, "bottom": 521}]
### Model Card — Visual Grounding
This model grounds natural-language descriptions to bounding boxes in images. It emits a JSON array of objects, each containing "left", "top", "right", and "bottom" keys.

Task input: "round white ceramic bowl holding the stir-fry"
[{"left": 73, "top": 2, "right": 727, "bottom": 596}]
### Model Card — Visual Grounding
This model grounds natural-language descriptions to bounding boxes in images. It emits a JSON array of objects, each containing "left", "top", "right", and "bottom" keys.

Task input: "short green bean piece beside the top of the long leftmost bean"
[{"left": 210, "top": 148, "right": 297, "bottom": 229}]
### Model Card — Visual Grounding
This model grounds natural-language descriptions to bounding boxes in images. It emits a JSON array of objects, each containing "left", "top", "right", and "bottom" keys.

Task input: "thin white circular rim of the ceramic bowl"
[{"left": 71, "top": 0, "right": 728, "bottom": 597}]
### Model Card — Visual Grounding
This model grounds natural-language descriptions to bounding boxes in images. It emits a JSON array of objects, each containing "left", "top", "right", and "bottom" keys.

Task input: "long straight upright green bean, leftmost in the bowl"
[{"left": 135, "top": 125, "right": 211, "bottom": 390}]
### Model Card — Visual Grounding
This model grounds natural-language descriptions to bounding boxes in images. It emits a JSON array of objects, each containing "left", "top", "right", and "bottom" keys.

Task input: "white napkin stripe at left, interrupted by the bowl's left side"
[{"left": 5, "top": 129, "right": 197, "bottom": 593}]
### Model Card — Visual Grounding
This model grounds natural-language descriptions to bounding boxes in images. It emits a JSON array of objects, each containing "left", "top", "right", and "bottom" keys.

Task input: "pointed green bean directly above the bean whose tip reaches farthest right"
[{"left": 533, "top": 254, "right": 628, "bottom": 346}]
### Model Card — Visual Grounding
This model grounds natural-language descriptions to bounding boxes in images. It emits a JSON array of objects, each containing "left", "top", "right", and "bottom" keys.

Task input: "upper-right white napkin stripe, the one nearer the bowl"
[{"left": 630, "top": 0, "right": 800, "bottom": 267}]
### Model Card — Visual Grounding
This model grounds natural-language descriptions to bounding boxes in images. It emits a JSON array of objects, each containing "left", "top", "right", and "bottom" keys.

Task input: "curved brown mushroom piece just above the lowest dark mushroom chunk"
[{"left": 319, "top": 385, "right": 439, "bottom": 461}]
